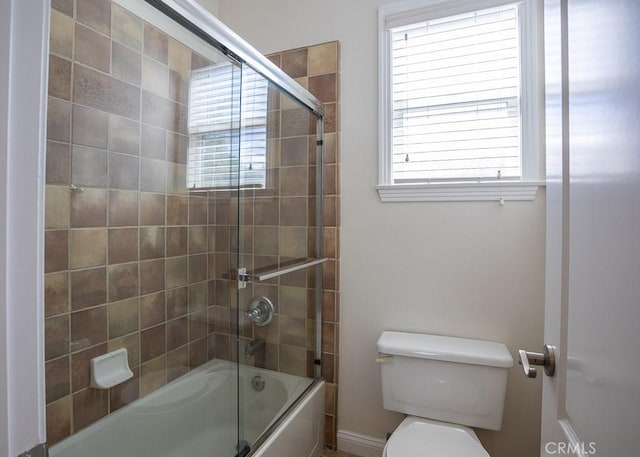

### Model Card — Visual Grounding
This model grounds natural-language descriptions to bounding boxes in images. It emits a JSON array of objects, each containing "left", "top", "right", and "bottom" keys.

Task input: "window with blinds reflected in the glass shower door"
[{"left": 187, "top": 62, "right": 268, "bottom": 190}]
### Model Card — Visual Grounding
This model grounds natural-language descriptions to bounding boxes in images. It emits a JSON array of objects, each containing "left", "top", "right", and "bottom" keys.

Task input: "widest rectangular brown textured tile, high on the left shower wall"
[{"left": 73, "top": 65, "right": 140, "bottom": 120}]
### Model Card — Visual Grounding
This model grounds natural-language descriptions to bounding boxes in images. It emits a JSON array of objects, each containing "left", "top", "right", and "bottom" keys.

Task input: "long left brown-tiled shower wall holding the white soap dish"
[{"left": 45, "top": 0, "right": 216, "bottom": 444}]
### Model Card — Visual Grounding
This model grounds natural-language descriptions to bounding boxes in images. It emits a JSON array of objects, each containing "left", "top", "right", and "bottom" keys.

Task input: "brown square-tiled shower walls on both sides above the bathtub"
[{"left": 45, "top": 0, "right": 340, "bottom": 448}]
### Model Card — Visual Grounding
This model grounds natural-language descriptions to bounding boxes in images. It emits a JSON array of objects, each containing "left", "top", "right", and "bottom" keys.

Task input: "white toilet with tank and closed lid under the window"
[{"left": 377, "top": 332, "right": 513, "bottom": 457}]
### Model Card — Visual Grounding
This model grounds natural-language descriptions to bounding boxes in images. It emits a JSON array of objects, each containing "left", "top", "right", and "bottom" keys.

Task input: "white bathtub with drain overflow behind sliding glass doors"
[{"left": 49, "top": 359, "right": 325, "bottom": 457}]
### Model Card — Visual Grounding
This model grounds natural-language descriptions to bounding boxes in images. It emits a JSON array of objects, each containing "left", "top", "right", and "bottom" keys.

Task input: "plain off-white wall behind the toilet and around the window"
[{"left": 210, "top": 0, "right": 545, "bottom": 457}]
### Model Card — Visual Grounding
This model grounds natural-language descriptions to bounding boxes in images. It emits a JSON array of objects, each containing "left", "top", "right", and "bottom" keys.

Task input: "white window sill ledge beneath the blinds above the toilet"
[{"left": 376, "top": 181, "right": 545, "bottom": 203}]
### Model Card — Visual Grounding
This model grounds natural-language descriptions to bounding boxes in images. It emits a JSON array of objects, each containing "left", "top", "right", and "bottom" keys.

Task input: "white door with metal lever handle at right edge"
[{"left": 538, "top": 0, "right": 640, "bottom": 457}]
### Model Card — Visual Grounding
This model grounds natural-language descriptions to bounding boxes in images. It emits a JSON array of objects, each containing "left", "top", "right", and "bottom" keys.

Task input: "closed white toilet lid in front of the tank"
[{"left": 382, "top": 416, "right": 490, "bottom": 457}]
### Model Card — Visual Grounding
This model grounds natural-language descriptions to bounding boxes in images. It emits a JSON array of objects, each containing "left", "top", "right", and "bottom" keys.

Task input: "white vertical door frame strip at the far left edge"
[{"left": 0, "top": 0, "right": 49, "bottom": 457}]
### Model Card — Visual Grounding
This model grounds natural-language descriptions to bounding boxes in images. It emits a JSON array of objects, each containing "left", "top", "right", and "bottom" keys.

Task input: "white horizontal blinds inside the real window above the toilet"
[{"left": 390, "top": 5, "right": 521, "bottom": 183}]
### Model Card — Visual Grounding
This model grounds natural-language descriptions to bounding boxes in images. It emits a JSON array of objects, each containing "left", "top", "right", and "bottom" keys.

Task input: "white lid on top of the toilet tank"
[{"left": 378, "top": 332, "right": 513, "bottom": 368}]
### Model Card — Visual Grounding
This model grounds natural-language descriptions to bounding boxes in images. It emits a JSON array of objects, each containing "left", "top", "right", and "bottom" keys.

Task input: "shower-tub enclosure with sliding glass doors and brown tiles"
[{"left": 45, "top": 0, "right": 327, "bottom": 457}]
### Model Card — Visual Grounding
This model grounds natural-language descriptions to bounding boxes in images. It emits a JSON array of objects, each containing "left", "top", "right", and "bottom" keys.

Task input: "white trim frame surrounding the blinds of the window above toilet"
[{"left": 376, "top": 0, "right": 544, "bottom": 202}]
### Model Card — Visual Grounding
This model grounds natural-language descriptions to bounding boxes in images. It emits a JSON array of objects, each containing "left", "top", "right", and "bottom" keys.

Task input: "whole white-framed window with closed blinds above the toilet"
[{"left": 378, "top": 0, "right": 539, "bottom": 201}]
